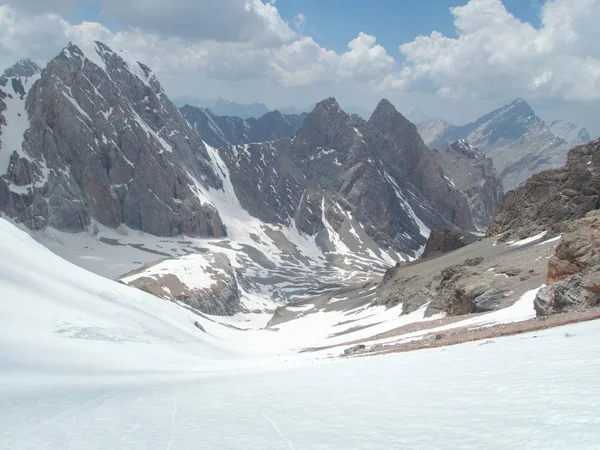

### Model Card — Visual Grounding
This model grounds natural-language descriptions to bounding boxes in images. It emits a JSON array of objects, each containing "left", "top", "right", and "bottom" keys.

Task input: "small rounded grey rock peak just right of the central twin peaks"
[{"left": 433, "top": 139, "right": 504, "bottom": 231}]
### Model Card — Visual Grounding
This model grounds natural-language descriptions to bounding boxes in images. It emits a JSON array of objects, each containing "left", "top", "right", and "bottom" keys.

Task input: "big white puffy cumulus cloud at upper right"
[{"left": 383, "top": 0, "right": 600, "bottom": 100}]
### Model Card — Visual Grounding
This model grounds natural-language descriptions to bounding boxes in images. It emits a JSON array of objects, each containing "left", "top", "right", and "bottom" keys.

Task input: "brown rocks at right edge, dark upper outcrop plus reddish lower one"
[{"left": 488, "top": 140, "right": 600, "bottom": 316}]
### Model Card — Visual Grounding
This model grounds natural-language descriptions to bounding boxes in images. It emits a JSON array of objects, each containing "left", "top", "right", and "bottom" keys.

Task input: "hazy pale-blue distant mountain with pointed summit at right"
[{"left": 419, "top": 98, "right": 587, "bottom": 190}]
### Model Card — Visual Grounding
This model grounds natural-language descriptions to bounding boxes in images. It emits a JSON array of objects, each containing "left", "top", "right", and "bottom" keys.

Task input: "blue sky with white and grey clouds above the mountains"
[{"left": 0, "top": 0, "right": 600, "bottom": 135}]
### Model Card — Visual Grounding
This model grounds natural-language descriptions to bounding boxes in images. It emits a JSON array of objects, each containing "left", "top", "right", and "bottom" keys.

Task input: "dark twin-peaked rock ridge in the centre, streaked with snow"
[{"left": 213, "top": 98, "right": 480, "bottom": 257}]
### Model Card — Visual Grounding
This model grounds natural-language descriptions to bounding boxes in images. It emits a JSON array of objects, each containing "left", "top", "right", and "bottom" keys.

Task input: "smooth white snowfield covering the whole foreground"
[{"left": 0, "top": 219, "right": 600, "bottom": 450}]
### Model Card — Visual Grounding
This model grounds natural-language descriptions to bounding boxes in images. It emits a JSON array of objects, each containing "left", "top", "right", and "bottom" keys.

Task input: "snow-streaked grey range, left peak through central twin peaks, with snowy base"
[{"left": 0, "top": 42, "right": 506, "bottom": 314}]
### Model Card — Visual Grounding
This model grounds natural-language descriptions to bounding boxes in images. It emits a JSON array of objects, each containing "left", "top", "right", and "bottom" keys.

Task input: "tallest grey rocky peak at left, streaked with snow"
[{"left": 0, "top": 42, "right": 225, "bottom": 236}]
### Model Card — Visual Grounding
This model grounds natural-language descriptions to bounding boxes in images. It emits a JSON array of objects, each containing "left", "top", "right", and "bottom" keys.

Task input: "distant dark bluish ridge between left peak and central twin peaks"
[{"left": 180, "top": 105, "right": 306, "bottom": 147}]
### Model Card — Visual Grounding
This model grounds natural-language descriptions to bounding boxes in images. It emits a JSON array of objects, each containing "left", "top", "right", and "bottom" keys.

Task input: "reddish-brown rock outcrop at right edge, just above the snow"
[{"left": 534, "top": 210, "right": 600, "bottom": 316}]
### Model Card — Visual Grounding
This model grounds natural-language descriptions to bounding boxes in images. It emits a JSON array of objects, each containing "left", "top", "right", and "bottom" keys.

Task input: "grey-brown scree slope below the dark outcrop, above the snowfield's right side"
[{"left": 373, "top": 232, "right": 557, "bottom": 316}]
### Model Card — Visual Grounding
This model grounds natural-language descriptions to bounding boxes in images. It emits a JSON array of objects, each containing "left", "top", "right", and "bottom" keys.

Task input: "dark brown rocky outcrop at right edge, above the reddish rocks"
[{"left": 488, "top": 140, "right": 600, "bottom": 239}]
